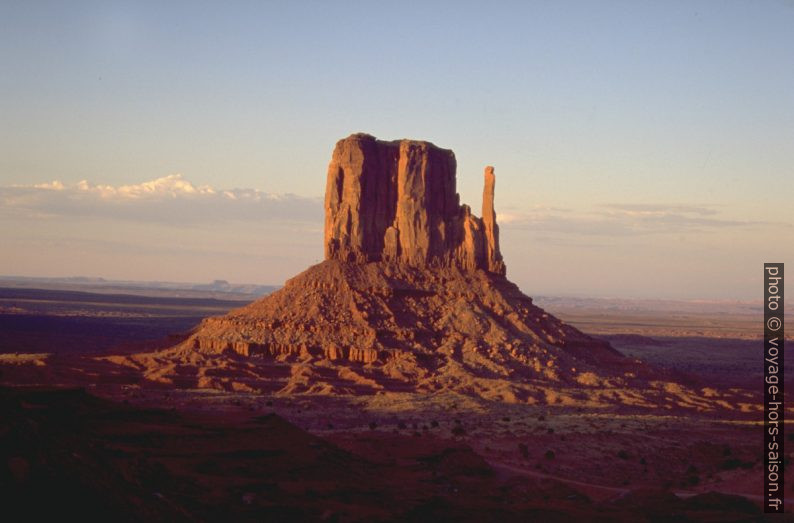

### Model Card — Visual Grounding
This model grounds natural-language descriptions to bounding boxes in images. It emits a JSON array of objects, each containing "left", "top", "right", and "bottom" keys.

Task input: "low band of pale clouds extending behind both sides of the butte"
[{"left": 6, "top": 178, "right": 776, "bottom": 237}]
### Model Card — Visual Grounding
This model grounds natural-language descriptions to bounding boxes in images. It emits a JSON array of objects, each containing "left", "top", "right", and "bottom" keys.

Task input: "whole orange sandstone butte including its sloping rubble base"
[{"left": 116, "top": 134, "right": 695, "bottom": 406}]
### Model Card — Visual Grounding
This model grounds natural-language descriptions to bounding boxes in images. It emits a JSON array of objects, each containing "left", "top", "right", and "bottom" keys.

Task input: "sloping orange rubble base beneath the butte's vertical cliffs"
[{"left": 170, "top": 260, "right": 640, "bottom": 398}]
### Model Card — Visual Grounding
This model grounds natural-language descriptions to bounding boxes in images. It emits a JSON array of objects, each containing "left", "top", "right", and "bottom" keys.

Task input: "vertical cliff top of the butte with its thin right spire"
[{"left": 325, "top": 134, "right": 505, "bottom": 275}]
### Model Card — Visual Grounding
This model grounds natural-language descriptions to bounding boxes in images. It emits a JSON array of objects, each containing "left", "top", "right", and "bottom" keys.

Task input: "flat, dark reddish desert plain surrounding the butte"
[{"left": 0, "top": 288, "right": 794, "bottom": 521}]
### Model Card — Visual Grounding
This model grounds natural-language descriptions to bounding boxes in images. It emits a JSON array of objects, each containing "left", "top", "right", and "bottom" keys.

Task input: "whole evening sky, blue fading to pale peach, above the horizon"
[{"left": 0, "top": 0, "right": 794, "bottom": 299}]
